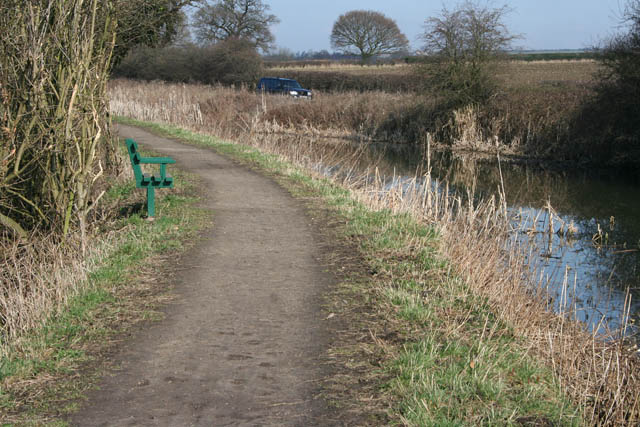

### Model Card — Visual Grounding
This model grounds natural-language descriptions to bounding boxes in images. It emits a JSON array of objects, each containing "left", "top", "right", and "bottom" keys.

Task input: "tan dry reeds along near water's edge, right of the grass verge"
[{"left": 111, "top": 82, "right": 640, "bottom": 425}]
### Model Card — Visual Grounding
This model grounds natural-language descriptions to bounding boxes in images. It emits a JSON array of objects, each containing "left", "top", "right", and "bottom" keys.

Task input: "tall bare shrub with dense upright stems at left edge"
[{"left": 0, "top": 0, "right": 115, "bottom": 238}]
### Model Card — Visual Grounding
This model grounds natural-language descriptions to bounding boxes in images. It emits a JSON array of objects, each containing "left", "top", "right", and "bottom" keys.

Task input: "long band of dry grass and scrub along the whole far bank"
[{"left": 111, "top": 73, "right": 588, "bottom": 160}]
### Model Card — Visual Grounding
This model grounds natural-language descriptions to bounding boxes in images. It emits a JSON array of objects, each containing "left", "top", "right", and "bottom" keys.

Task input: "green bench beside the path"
[{"left": 125, "top": 138, "right": 176, "bottom": 218}]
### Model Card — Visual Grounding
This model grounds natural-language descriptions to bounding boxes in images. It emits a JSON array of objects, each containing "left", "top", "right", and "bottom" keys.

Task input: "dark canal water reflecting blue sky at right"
[{"left": 324, "top": 140, "right": 640, "bottom": 335}]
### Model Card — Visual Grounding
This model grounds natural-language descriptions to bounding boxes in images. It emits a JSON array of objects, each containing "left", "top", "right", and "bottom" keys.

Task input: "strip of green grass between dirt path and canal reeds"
[{"left": 115, "top": 118, "right": 582, "bottom": 425}]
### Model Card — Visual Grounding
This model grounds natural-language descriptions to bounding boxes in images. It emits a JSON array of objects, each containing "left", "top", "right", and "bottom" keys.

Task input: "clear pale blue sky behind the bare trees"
[{"left": 264, "top": 0, "right": 625, "bottom": 52}]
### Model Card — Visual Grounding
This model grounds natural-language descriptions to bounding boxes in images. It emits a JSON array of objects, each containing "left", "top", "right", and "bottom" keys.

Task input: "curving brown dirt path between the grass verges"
[{"left": 71, "top": 126, "right": 333, "bottom": 426}]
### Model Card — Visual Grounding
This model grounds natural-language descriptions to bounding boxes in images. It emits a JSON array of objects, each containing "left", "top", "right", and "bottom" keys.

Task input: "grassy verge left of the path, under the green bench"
[{"left": 0, "top": 145, "right": 209, "bottom": 425}]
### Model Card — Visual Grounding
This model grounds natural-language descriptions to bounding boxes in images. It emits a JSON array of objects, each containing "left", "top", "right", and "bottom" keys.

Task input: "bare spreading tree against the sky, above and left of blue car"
[{"left": 193, "top": 0, "right": 280, "bottom": 52}]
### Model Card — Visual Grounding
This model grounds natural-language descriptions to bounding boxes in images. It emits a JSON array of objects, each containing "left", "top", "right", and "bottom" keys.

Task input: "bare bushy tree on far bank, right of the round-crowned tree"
[{"left": 422, "top": 0, "right": 520, "bottom": 103}]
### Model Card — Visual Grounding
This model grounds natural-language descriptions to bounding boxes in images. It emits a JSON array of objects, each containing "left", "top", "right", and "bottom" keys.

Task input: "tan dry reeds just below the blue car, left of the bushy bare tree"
[{"left": 111, "top": 80, "right": 413, "bottom": 138}]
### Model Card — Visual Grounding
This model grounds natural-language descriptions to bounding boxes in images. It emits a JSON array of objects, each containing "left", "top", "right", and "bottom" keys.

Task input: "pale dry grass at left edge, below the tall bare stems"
[{"left": 0, "top": 157, "right": 133, "bottom": 359}]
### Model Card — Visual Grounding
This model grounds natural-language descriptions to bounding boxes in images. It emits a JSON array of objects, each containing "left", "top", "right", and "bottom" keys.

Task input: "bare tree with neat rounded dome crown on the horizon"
[{"left": 331, "top": 10, "right": 409, "bottom": 62}]
